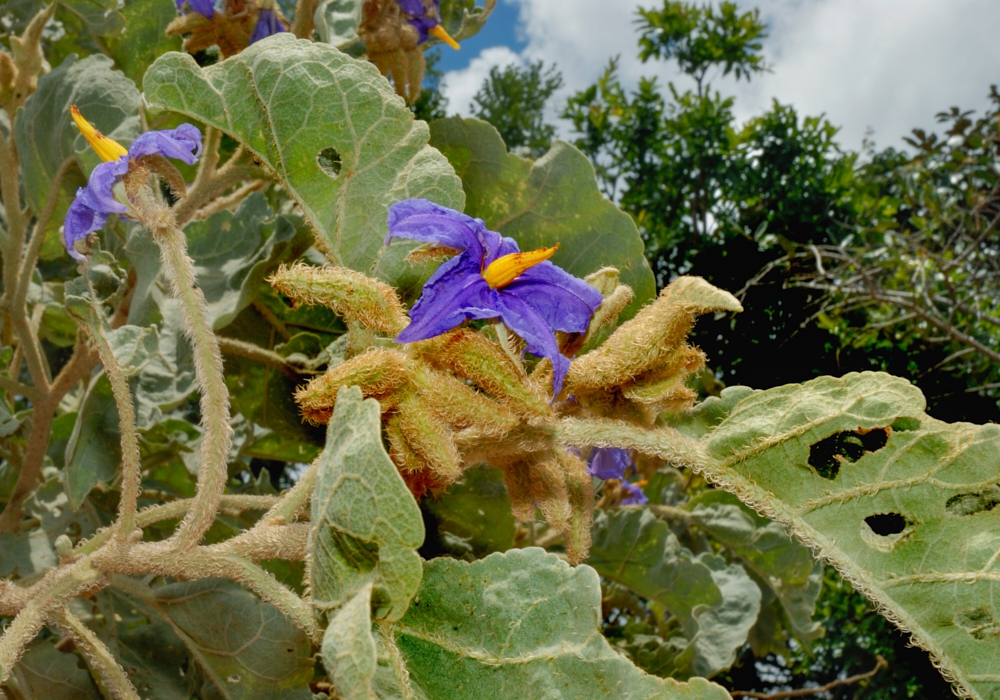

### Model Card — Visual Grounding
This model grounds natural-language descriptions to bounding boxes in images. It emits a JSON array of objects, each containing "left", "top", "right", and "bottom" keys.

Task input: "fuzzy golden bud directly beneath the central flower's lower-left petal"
[{"left": 415, "top": 328, "right": 552, "bottom": 416}]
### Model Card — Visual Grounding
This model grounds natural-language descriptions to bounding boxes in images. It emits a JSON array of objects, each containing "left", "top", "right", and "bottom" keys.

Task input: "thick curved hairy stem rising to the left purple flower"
[{"left": 135, "top": 184, "right": 233, "bottom": 549}]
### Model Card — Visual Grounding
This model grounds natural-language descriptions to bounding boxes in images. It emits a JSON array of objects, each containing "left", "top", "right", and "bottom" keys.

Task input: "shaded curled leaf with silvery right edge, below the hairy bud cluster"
[{"left": 588, "top": 509, "right": 760, "bottom": 677}]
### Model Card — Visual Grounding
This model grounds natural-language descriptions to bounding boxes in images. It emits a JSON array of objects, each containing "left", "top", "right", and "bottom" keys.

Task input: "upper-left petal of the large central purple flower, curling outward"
[{"left": 385, "top": 199, "right": 501, "bottom": 265}]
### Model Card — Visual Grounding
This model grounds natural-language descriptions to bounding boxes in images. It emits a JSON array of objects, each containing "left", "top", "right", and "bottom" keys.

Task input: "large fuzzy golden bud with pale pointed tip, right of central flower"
[{"left": 566, "top": 277, "right": 743, "bottom": 394}]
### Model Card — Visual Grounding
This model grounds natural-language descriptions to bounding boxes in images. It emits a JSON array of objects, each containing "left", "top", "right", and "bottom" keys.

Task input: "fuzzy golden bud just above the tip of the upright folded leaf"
[{"left": 295, "top": 348, "right": 411, "bottom": 425}]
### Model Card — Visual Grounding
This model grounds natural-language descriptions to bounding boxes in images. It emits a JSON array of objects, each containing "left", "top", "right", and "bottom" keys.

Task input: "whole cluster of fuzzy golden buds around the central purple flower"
[{"left": 270, "top": 264, "right": 742, "bottom": 562}]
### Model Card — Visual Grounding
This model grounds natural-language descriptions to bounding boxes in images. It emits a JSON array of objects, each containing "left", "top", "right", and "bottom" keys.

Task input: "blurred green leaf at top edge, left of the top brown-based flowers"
[{"left": 106, "top": 0, "right": 181, "bottom": 81}]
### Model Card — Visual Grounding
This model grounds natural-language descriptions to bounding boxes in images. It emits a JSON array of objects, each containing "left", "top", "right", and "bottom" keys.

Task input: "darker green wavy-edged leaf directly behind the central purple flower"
[{"left": 431, "top": 117, "right": 656, "bottom": 319}]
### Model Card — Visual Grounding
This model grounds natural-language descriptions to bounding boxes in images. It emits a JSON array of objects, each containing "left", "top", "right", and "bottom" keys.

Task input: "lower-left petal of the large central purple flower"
[{"left": 396, "top": 255, "right": 500, "bottom": 343}]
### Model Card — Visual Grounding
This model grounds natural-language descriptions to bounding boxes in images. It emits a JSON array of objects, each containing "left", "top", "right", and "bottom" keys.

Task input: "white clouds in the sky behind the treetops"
[{"left": 446, "top": 0, "right": 1000, "bottom": 149}]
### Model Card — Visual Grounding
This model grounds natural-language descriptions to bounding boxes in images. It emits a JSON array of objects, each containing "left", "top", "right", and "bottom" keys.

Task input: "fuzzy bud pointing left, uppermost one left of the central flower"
[{"left": 268, "top": 263, "right": 408, "bottom": 336}]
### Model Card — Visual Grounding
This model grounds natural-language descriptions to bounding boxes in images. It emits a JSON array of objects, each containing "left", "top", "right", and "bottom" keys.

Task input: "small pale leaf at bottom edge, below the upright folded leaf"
[{"left": 320, "top": 582, "right": 378, "bottom": 700}]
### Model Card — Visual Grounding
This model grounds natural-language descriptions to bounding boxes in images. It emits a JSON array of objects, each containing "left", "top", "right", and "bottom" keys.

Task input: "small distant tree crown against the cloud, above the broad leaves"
[{"left": 469, "top": 61, "right": 563, "bottom": 158}]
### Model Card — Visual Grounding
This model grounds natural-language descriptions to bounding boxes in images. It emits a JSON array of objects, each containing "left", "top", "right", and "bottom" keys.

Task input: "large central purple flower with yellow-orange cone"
[{"left": 385, "top": 199, "right": 602, "bottom": 397}]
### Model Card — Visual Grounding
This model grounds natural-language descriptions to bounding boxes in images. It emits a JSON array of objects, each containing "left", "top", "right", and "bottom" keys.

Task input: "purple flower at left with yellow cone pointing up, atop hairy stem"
[{"left": 63, "top": 105, "right": 201, "bottom": 260}]
